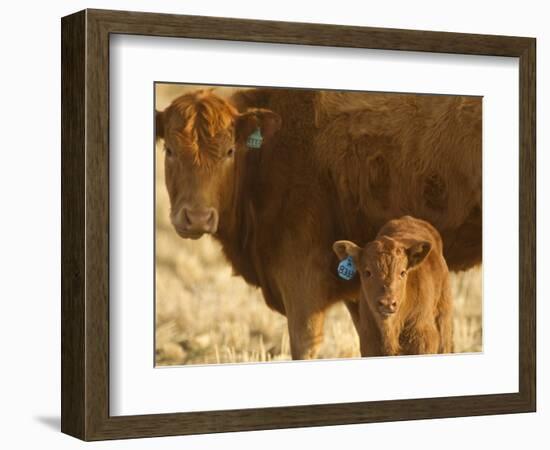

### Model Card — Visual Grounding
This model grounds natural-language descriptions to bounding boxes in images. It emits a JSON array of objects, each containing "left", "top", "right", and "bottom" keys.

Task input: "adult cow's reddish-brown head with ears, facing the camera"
[{"left": 155, "top": 90, "right": 281, "bottom": 239}]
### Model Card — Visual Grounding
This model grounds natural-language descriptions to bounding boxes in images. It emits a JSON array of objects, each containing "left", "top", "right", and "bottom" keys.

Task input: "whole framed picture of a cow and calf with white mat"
[{"left": 61, "top": 10, "right": 536, "bottom": 440}]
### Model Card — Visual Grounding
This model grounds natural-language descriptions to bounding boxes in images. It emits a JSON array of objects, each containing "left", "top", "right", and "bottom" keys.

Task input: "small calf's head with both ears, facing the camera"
[{"left": 333, "top": 237, "right": 431, "bottom": 319}]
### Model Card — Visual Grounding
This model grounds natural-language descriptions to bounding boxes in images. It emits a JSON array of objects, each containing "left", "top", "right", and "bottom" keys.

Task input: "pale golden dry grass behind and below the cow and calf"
[{"left": 156, "top": 86, "right": 482, "bottom": 365}]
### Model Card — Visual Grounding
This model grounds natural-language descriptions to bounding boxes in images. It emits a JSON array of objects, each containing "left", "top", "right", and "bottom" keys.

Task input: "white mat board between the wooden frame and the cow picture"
[{"left": 109, "top": 36, "right": 519, "bottom": 415}]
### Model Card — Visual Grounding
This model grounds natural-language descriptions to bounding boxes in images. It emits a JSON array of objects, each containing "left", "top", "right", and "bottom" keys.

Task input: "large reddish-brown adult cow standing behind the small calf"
[{"left": 156, "top": 89, "right": 481, "bottom": 359}]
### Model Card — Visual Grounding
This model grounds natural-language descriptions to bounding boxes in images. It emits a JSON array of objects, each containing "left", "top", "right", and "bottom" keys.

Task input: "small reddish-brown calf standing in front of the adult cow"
[{"left": 333, "top": 216, "right": 453, "bottom": 356}]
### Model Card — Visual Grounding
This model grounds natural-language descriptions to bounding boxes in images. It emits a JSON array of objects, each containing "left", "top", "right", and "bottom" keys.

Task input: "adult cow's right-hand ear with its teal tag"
[{"left": 235, "top": 109, "right": 283, "bottom": 148}]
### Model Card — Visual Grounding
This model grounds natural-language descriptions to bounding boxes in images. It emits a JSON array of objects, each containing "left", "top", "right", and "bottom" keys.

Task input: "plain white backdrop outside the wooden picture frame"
[{"left": 0, "top": 0, "right": 550, "bottom": 449}]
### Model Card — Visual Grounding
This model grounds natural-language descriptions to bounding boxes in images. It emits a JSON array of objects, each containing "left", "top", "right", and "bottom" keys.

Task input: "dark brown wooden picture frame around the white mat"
[{"left": 61, "top": 10, "right": 536, "bottom": 440}]
